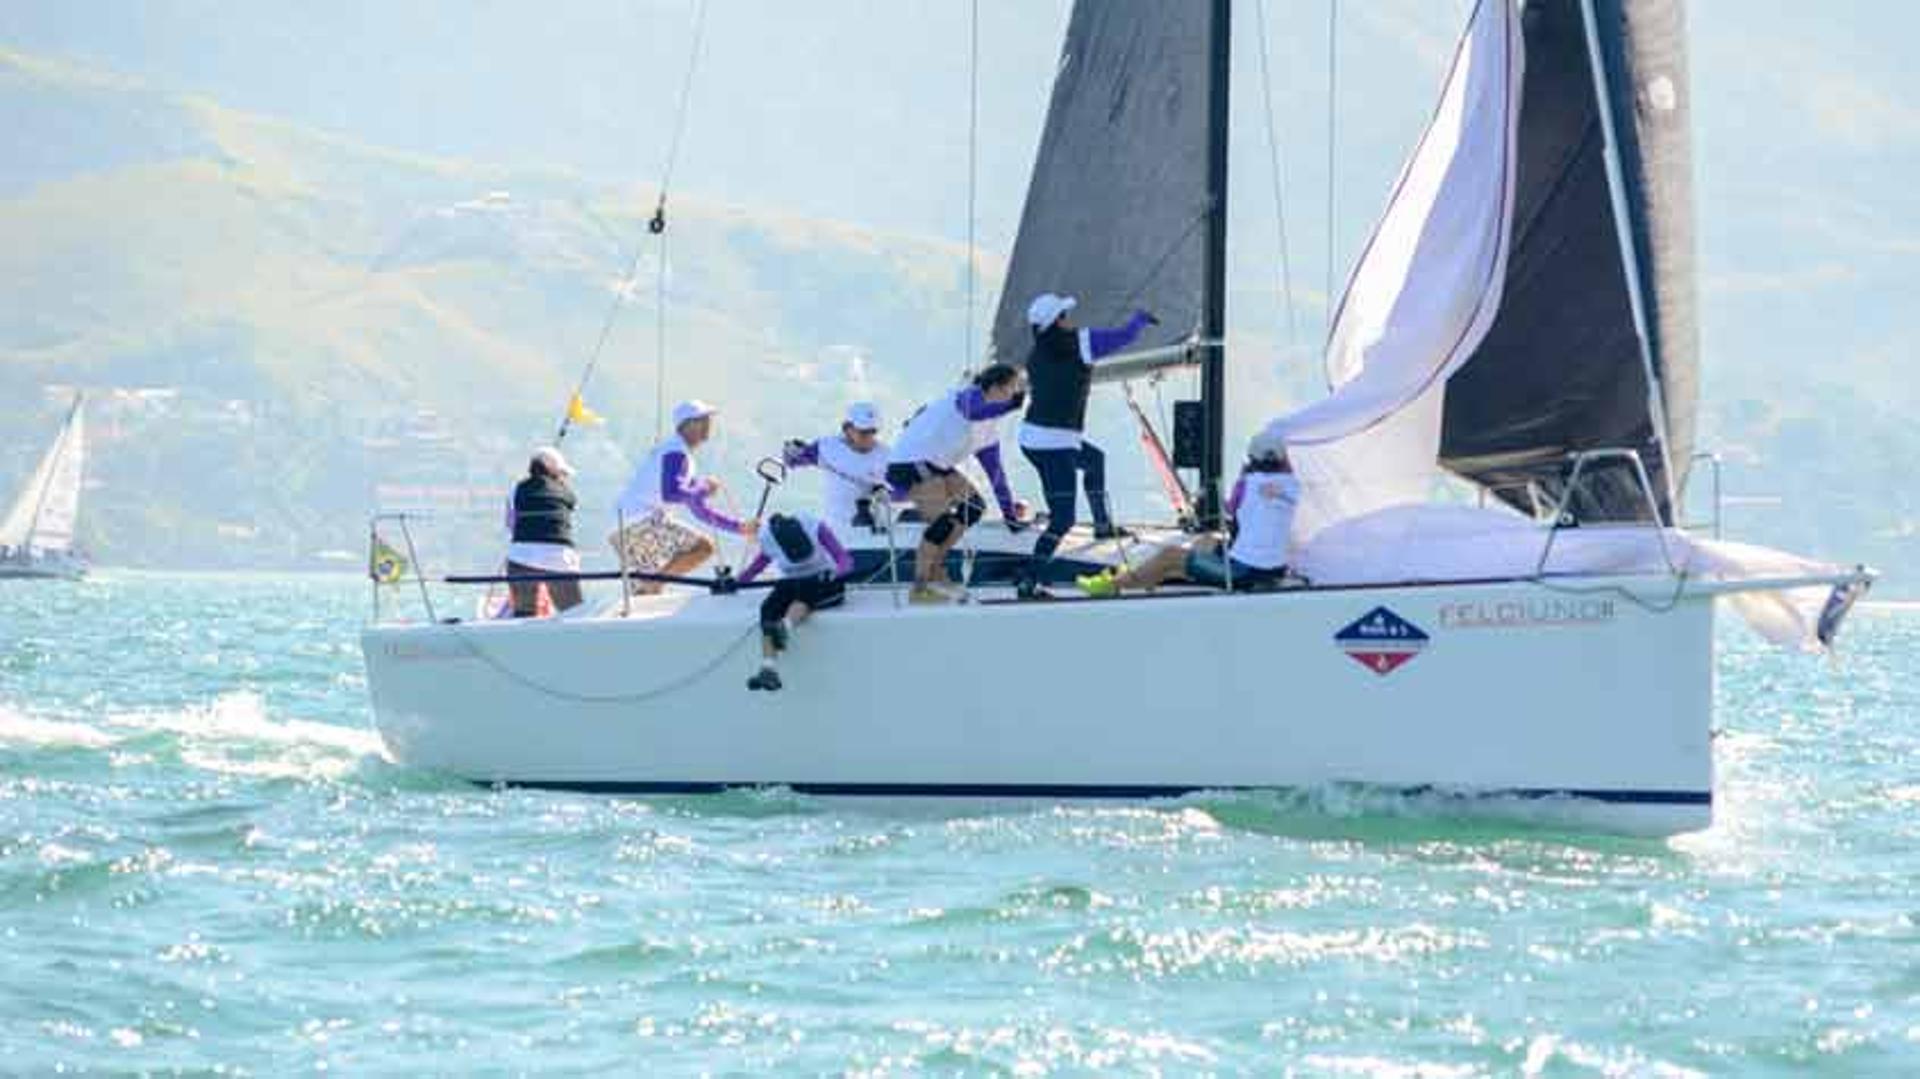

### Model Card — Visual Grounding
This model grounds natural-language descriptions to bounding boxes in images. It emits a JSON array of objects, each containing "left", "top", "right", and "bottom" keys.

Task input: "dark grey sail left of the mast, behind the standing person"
[{"left": 993, "top": 0, "right": 1215, "bottom": 363}]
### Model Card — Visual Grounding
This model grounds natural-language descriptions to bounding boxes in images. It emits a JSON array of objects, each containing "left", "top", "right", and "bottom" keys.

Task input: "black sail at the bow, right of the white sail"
[{"left": 1440, "top": 0, "right": 1699, "bottom": 522}]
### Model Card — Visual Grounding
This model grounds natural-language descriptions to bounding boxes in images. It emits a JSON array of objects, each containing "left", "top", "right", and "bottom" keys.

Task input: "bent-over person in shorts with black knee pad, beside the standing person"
[{"left": 887, "top": 363, "right": 1025, "bottom": 603}]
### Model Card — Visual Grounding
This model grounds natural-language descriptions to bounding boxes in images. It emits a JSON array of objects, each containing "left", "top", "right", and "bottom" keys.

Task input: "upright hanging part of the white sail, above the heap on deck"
[{"left": 1275, "top": 0, "right": 1523, "bottom": 543}]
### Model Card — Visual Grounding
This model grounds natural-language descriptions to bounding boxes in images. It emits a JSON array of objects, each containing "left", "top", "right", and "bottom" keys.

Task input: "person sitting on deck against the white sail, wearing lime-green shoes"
[{"left": 1075, "top": 430, "right": 1300, "bottom": 599}]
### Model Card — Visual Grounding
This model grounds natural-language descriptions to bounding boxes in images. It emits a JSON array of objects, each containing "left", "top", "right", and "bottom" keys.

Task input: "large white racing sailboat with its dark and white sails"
[{"left": 363, "top": 0, "right": 1870, "bottom": 835}]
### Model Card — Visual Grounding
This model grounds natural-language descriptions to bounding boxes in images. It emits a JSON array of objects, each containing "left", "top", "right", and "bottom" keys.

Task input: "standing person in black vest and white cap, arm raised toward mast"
[{"left": 1020, "top": 292, "right": 1156, "bottom": 599}]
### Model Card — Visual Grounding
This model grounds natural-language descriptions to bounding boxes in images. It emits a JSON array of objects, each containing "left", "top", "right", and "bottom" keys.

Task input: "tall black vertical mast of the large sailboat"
[{"left": 1198, "top": 0, "right": 1233, "bottom": 528}]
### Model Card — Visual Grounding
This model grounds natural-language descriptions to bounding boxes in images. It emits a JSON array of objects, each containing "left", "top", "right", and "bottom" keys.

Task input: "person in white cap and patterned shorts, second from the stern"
[{"left": 611, "top": 399, "right": 760, "bottom": 593}]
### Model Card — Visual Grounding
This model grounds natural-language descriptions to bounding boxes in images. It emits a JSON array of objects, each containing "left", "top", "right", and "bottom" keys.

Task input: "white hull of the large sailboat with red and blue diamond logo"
[{"left": 363, "top": 580, "right": 1713, "bottom": 835}]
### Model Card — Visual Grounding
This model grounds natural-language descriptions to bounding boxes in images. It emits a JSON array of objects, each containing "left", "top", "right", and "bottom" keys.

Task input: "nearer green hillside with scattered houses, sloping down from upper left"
[{"left": 0, "top": 50, "right": 1920, "bottom": 589}]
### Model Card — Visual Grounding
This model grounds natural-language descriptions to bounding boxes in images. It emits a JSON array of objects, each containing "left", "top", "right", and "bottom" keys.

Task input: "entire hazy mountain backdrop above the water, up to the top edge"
[{"left": 0, "top": 0, "right": 1920, "bottom": 587}]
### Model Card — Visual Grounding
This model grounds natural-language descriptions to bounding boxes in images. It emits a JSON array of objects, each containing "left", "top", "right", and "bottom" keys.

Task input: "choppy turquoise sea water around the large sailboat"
[{"left": 0, "top": 574, "right": 1920, "bottom": 1077}]
